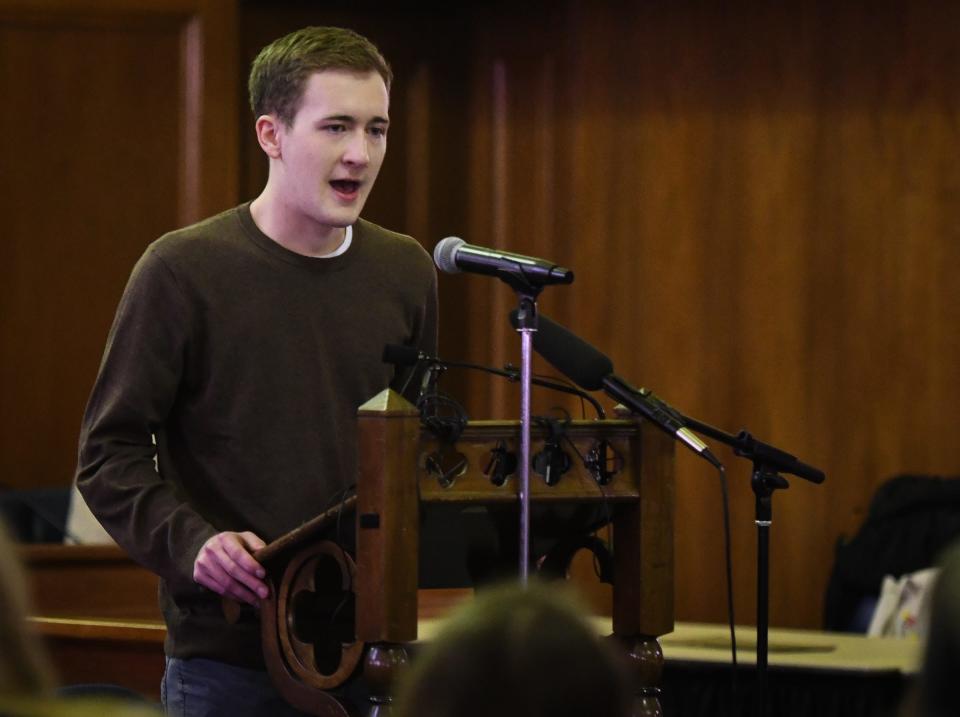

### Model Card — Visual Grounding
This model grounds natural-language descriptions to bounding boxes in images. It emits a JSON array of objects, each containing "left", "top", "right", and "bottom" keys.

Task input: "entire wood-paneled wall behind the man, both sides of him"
[{"left": 0, "top": 0, "right": 960, "bottom": 627}]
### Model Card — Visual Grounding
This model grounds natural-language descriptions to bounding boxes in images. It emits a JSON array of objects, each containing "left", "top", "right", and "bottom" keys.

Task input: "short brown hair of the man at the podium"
[{"left": 248, "top": 27, "right": 393, "bottom": 127}]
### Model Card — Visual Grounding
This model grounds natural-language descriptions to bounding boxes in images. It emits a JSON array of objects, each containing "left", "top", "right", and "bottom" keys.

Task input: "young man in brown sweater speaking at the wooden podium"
[{"left": 77, "top": 27, "right": 437, "bottom": 717}]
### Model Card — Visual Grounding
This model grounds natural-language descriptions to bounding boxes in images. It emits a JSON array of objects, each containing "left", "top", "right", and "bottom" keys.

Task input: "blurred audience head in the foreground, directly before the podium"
[{"left": 395, "top": 583, "right": 631, "bottom": 717}]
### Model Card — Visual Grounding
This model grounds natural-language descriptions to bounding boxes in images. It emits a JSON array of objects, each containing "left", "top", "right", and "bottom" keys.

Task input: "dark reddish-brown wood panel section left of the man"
[{"left": 0, "top": 0, "right": 238, "bottom": 487}]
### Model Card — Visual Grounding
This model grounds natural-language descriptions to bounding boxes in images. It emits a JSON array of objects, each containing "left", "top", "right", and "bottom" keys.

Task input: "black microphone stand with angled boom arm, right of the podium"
[{"left": 681, "top": 415, "right": 825, "bottom": 717}]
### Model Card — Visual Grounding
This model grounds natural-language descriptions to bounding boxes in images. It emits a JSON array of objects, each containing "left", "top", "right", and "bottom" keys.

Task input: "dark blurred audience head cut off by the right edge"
[{"left": 904, "top": 543, "right": 960, "bottom": 717}]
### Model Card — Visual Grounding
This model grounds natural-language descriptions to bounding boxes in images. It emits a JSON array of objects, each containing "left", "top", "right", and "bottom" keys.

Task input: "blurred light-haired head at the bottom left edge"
[{"left": 0, "top": 524, "right": 53, "bottom": 696}]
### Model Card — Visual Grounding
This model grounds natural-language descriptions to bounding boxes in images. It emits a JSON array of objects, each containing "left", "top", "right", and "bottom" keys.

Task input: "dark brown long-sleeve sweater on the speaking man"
[{"left": 77, "top": 204, "right": 437, "bottom": 666}]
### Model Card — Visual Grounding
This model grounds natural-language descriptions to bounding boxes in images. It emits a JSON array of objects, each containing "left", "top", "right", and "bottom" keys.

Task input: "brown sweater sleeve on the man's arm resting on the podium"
[{"left": 77, "top": 248, "right": 217, "bottom": 593}]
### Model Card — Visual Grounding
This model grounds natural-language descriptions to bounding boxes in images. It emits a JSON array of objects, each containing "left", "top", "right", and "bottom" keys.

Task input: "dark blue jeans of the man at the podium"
[{"left": 160, "top": 657, "right": 316, "bottom": 717}]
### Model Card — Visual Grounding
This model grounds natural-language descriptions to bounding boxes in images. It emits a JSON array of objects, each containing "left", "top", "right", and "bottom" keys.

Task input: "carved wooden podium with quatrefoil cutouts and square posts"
[{"left": 261, "top": 390, "right": 674, "bottom": 716}]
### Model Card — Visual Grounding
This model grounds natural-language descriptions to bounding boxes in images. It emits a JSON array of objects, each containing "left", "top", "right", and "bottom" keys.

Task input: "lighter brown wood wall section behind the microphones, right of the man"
[{"left": 436, "top": 2, "right": 960, "bottom": 627}]
